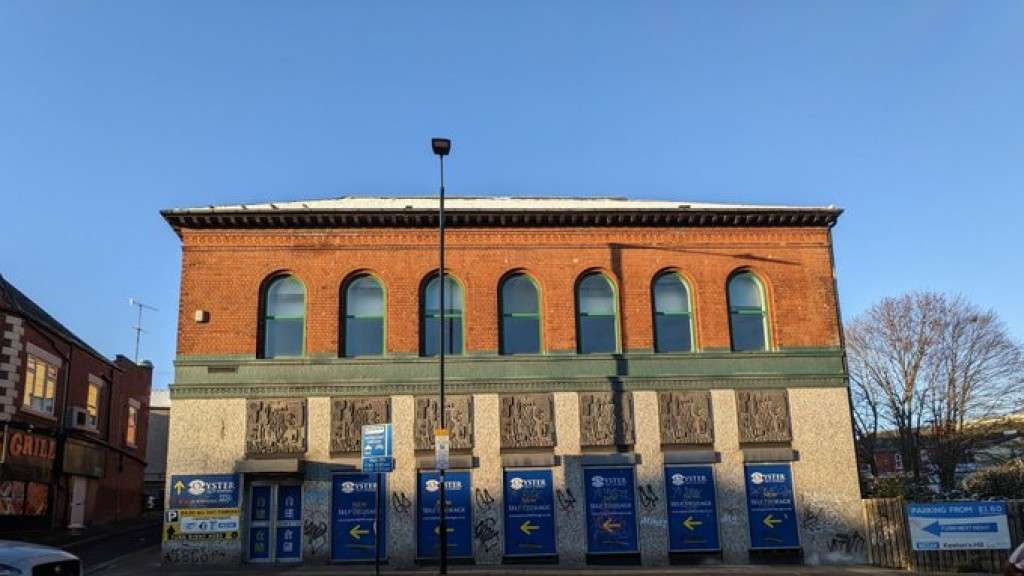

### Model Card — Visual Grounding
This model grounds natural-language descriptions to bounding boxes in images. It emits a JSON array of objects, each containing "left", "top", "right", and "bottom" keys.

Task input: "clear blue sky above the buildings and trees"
[{"left": 0, "top": 0, "right": 1024, "bottom": 386}]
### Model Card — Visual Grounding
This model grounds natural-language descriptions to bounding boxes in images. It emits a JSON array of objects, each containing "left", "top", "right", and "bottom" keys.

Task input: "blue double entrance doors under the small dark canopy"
[{"left": 247, "top": 482, "right": 302, "bottom": 563}]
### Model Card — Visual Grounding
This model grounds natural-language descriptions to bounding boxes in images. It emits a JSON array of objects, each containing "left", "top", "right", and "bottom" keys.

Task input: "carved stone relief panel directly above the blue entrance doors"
[{"left": 246, "top": 398, "right": 306, "bottom": 456}]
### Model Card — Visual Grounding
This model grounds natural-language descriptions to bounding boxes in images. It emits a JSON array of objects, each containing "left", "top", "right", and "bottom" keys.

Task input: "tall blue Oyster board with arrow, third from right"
[{"left": 583, "top": 466, "right": 640, "bottom": 554}]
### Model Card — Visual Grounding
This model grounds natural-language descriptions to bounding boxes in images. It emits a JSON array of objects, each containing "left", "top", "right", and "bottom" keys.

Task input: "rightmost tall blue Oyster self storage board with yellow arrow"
[{"left": 743, "top": 464, "right": 800, "bottom": 549}]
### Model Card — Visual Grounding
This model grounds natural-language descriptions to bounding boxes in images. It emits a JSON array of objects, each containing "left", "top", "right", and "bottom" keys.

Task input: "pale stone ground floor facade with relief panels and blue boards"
[{"left": 164, "top": 382, "right": 866, "bottom": 568}]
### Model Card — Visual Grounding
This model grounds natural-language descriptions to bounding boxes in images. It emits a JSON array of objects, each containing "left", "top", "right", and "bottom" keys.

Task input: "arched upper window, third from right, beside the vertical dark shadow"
[{"left": 577, "top": 272, "right": 618, "bottom": 354}]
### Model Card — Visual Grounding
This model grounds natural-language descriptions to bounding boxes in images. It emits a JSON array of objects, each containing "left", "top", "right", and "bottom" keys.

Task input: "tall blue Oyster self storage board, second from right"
[{"left": 665, "top": 466, "right": 722, "bottom": 552}]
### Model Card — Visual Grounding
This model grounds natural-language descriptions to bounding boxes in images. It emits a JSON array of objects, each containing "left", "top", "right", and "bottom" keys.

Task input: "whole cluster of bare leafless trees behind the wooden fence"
[{"left": 846, "top": 292, "right": 1024, "bottom": 490}]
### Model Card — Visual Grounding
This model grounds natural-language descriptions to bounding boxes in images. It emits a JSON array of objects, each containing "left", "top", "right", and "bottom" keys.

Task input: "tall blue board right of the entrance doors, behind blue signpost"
[{"left": 331, "top": 474, "right": 387, "bottom": 562}]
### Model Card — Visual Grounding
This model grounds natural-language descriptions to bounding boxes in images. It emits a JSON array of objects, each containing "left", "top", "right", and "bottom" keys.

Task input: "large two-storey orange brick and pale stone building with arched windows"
[{"left": 163, "top": 198, "right": 863, "bottom": 566}]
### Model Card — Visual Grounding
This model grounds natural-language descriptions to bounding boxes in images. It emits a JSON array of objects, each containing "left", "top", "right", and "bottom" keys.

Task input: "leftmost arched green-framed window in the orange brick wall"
[{"left": 261, "top": 276, "right": 306, "bottom": 358}]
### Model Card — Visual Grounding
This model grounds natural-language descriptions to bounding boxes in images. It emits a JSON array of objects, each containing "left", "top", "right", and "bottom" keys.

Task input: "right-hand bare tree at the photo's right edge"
[{"left": 926, "top": 296, "right": 1024, "bottom": 491}]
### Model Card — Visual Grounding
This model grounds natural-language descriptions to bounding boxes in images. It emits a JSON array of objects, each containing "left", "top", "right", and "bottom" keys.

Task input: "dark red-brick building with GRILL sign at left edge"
[{"left": 0, "top": 277, "right": 153, "bottom": 537}]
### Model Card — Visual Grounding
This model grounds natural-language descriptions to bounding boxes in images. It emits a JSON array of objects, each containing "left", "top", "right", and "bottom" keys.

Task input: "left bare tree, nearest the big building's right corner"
[{"left": 846, "top": 293, "right": 942, "bottom": 480}]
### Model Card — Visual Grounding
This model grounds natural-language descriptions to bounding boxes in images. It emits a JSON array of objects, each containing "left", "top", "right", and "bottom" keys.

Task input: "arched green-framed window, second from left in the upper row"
[{"left": 344, "top": 275, "right": 384, "bottom": 357}]
